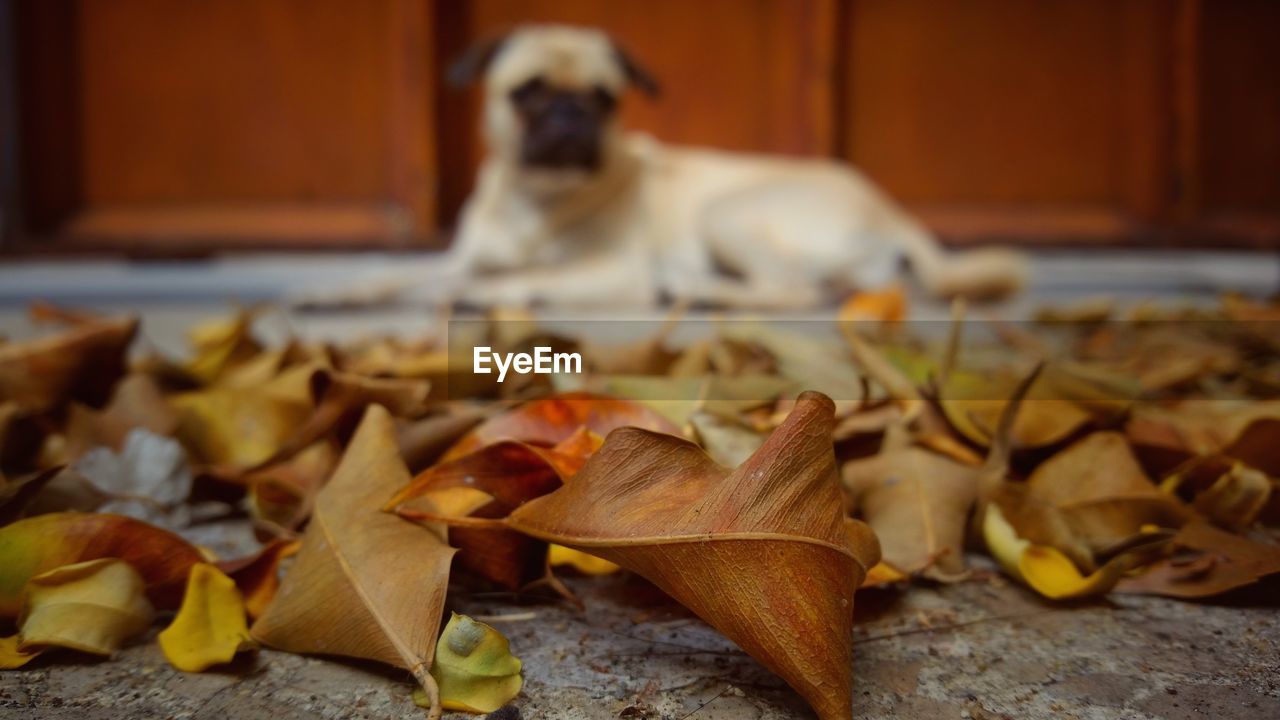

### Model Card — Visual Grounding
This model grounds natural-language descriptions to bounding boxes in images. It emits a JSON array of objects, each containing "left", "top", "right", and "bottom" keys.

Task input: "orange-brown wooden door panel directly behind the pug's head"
[{"left": 438, "top": 0, "right": 836, "bottom": 222}]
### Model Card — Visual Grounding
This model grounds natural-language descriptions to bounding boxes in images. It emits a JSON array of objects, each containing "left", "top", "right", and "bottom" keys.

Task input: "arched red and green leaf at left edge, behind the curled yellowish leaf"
[{"left": 0, "top": 512, "right": 201, "bottom": 618}]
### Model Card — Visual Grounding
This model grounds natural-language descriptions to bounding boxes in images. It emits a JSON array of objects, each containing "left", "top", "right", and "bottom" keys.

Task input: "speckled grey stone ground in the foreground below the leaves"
[{"left": 0, "top": 561, "right": 1280, "bottom": 720}]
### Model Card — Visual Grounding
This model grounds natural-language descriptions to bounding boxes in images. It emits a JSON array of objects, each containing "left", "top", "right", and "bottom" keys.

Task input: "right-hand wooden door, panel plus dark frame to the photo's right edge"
[{"left": 841, "top": 0, "right": 1280, "bottom": 246}]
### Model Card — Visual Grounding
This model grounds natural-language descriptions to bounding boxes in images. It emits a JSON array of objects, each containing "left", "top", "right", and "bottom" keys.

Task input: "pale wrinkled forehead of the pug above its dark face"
[{"left": 488, "top": 27, "right": 626, "bottom": 91}]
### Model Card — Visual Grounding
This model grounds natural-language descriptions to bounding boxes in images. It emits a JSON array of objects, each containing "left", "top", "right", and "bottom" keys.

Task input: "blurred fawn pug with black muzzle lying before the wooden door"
[{"left": 449, "top": 26, "right": 1024, "bottom": 309}]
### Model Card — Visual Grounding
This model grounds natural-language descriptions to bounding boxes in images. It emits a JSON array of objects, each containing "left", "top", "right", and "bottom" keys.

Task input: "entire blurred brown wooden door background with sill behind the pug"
[{"left": 0, "top": 0, "right": 1280, "bottom": 324}]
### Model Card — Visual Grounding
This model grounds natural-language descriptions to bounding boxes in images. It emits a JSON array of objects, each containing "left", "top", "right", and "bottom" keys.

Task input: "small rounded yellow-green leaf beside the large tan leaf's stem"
[{"left": 413, "top": 612, "right": 524, "bottom": 712}]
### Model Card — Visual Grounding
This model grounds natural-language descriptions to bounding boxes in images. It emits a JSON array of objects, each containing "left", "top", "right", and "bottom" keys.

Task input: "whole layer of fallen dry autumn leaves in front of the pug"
[{"left": 0, "top": 293, "right": 1280, "bottom": 719}]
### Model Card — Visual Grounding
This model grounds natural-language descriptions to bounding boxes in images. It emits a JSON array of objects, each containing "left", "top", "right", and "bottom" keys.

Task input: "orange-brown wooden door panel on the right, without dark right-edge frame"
[{"left": 844, "top": 0, "right": 1167, "bottom": 242}]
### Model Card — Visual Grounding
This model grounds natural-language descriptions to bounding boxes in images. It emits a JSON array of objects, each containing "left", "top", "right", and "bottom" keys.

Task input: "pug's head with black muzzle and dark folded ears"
[{"left": 451, "top": 26, "right": 657, "bottom": 174}]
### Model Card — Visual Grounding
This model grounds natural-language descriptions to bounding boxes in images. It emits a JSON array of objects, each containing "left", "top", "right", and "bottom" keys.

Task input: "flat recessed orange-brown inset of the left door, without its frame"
[{"left": 79, "top": 0, "right": 390, "bottom": 205}]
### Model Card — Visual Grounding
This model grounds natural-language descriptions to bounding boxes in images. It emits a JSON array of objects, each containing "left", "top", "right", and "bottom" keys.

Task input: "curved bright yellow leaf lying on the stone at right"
[{"left": 982, "top": 503, "right": 1129, "bottom": 600}]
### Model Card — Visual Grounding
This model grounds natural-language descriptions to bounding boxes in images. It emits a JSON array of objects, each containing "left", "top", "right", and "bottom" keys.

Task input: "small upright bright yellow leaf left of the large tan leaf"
[{"left": 159, "top": 562, "right": 257, "bottom": 673}]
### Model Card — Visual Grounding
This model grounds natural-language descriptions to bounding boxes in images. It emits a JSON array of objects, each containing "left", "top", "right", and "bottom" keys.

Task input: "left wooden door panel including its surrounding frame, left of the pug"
[{"left": 19, "top": 0, "right": 435, "bottom": 243}]
